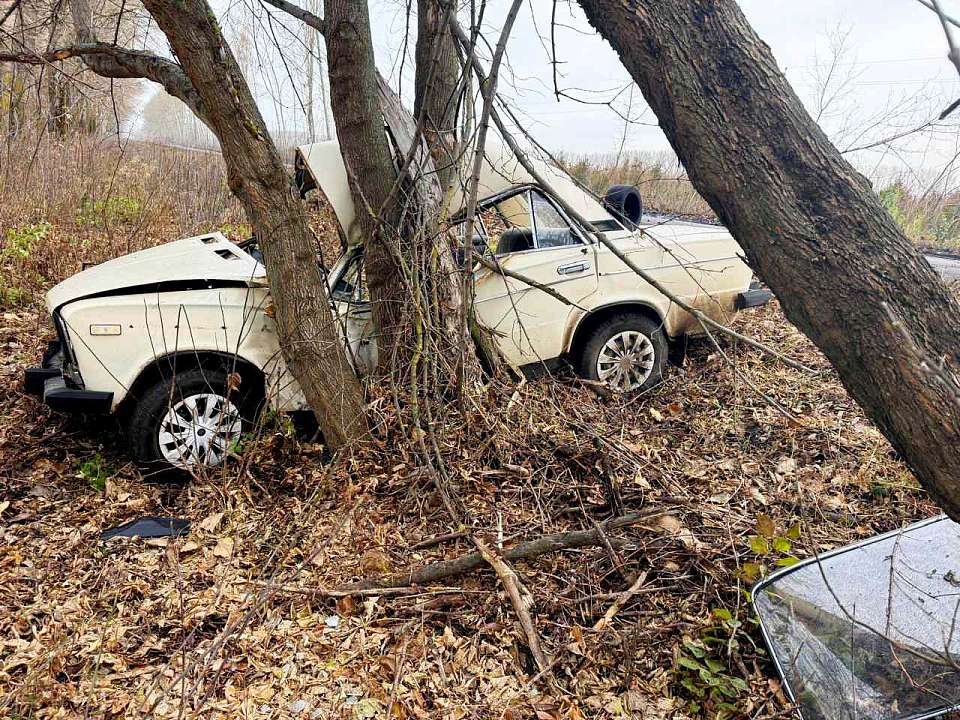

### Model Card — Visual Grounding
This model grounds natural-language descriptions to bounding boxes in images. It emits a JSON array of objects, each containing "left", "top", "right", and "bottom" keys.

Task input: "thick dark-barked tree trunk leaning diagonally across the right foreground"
[{"left": 580, "top": 0, "right": 960, "bottom": 520}]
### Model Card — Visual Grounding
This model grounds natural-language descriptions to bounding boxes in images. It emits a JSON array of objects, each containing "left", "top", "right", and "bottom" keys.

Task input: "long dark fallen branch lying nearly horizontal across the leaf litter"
[{"left": 335, "top": 509, "right": 669, "bottom": 594}]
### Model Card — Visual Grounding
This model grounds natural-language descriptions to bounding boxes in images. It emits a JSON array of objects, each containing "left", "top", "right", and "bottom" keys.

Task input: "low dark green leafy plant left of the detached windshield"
[{"left": 673, "top": 608, "right": 749, "bottom": 720}]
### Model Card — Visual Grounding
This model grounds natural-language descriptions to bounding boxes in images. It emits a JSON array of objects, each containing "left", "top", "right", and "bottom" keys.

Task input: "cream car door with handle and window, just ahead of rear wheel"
[{"left": 474, "top": 188, "right": 597, "bottom": 367}]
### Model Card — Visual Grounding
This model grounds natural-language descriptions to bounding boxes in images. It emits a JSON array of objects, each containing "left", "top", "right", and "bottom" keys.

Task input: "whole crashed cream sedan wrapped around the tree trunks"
[{"left": 25, "top": 142, "right": 770, "bottom": 468}]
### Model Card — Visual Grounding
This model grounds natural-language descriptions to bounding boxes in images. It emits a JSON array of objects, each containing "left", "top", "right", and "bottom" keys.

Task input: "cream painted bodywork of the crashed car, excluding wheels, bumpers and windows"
[{"left": 39, "top": 143, "right": 752, "bottom": 411}]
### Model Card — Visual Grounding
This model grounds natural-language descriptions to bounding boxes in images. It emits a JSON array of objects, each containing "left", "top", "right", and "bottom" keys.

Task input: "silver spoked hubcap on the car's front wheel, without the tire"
[{"left": 157, "top": 393, "right": 243, "bottom": 468}]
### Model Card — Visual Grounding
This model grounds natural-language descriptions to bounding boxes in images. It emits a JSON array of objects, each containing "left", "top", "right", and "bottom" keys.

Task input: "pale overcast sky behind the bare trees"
[{"left": 137, "top": 0, "right": 960, "bottom": 186}]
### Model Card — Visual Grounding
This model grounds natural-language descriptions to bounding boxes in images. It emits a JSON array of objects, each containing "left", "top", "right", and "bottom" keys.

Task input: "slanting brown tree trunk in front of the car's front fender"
[{"left": 143, "top": 0, "right": 366, "bottom": 449}]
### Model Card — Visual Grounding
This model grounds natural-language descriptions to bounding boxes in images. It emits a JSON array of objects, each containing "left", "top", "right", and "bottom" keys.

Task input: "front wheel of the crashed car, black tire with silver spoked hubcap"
[{"left": 125, "top": 367, "right": 263, "bottom": 472}]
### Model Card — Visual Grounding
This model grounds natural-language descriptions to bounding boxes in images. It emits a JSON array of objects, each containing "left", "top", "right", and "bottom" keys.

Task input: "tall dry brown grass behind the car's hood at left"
[{"left": 0, "top": 136, "right": 249, "bottom": 307}]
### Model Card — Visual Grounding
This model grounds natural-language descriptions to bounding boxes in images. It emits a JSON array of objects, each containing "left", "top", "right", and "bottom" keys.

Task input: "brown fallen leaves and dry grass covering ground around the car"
[{"left": 0, "top": 138, "right": 935, "bottom": 718}]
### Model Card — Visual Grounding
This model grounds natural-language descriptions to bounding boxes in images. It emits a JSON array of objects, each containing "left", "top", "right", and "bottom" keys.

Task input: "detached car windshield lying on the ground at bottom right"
[{"left": 753, "top": 518, "right": 960, "bottom": 720}]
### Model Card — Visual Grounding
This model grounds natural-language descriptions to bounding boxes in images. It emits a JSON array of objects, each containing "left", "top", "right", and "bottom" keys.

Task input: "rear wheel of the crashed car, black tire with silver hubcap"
[{"left": 576, "top": 313, "right": 668, "bottom": 392}]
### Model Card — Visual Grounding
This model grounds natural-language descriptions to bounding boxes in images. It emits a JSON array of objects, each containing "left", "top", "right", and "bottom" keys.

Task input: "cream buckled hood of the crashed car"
[{"left": 47, "top": 232, "right": 266, "bottom": 311}]
